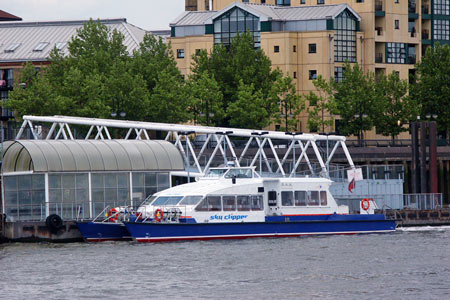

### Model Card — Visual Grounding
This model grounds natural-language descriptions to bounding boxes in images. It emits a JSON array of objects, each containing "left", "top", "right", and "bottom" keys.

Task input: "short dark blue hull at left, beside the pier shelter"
[{"left": 77, "top": 222, "right": 131, "bottom": 242}]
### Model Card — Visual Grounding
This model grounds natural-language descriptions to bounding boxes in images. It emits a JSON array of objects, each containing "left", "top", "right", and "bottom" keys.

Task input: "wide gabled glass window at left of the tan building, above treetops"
[{"left": 214, "top": 7, "right": 261, "bottom": 48}]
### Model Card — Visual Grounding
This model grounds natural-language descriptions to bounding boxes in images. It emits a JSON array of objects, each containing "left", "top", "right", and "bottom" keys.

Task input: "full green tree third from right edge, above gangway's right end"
[{"left": 331, "top": 63, "right": 381, "bottom": 143}]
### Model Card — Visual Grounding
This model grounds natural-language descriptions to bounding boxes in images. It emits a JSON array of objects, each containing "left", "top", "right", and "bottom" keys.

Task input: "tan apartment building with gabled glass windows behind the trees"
[{"left": 180, "top": 0, "right": 450, "bottom": 138}]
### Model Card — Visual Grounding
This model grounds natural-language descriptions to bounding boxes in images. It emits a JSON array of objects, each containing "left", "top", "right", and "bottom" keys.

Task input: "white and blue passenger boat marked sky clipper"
[{"left": 124, "top": 167, "right": 396, "bottom": 242}]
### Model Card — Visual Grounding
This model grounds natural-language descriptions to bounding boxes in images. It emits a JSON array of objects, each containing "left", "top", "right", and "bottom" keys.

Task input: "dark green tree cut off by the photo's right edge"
[{"left": 410, "top": 43, "right": 450, "bottom": 137}]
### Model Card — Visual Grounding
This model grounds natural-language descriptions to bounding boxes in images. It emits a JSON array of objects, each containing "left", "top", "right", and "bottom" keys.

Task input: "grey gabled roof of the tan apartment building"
[{"left": 171, "top": 2, "right": 361, "bottom": 26}]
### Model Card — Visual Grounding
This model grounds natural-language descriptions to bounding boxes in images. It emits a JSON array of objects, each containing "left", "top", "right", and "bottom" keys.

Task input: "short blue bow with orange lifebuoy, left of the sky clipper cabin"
[{"left": 76, "top": 206, "right": 135, "bottom": 242}]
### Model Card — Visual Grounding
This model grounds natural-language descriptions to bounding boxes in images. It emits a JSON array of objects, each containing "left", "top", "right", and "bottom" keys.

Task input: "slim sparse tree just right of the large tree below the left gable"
[{"left": 273, "top": 76, "right": 305, "bottom": 132}]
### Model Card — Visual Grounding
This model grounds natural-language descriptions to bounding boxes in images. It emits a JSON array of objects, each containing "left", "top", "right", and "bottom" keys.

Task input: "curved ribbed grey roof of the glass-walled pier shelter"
[{"left": 3, "top": 140, "right": 184, "bottom": 173}]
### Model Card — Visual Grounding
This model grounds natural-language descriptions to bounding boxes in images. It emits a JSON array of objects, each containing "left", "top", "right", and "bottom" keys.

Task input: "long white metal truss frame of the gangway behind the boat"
[{"left": 16, "top": 116, "right": 355, "bottom": 177}]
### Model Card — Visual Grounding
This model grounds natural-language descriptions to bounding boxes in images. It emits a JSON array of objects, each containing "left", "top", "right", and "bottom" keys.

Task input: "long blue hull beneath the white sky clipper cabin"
[{"left": 125, "top": 215, "right": 396, "bottom": 242}]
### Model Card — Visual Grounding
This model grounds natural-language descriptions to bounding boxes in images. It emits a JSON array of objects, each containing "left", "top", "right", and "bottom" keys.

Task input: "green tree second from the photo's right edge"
[{"left": 374, "top": 72, "right": 417, "bottom": 143}]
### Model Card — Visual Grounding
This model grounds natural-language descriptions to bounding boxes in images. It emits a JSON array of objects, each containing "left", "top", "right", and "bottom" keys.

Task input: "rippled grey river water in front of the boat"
[{"left": 0, "top": 227, "right": 450, "bottom": 299}]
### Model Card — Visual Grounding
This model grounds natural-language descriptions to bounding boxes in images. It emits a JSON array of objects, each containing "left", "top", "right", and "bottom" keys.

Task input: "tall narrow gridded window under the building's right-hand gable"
[{"left": 334, "top": 10, "right": 356, "bottom": 62}]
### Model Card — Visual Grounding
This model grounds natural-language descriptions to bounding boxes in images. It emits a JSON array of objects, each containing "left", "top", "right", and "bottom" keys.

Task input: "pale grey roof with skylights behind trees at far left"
[{"left": 0, "top": 19, "right": 146, "bottom": 62}]
